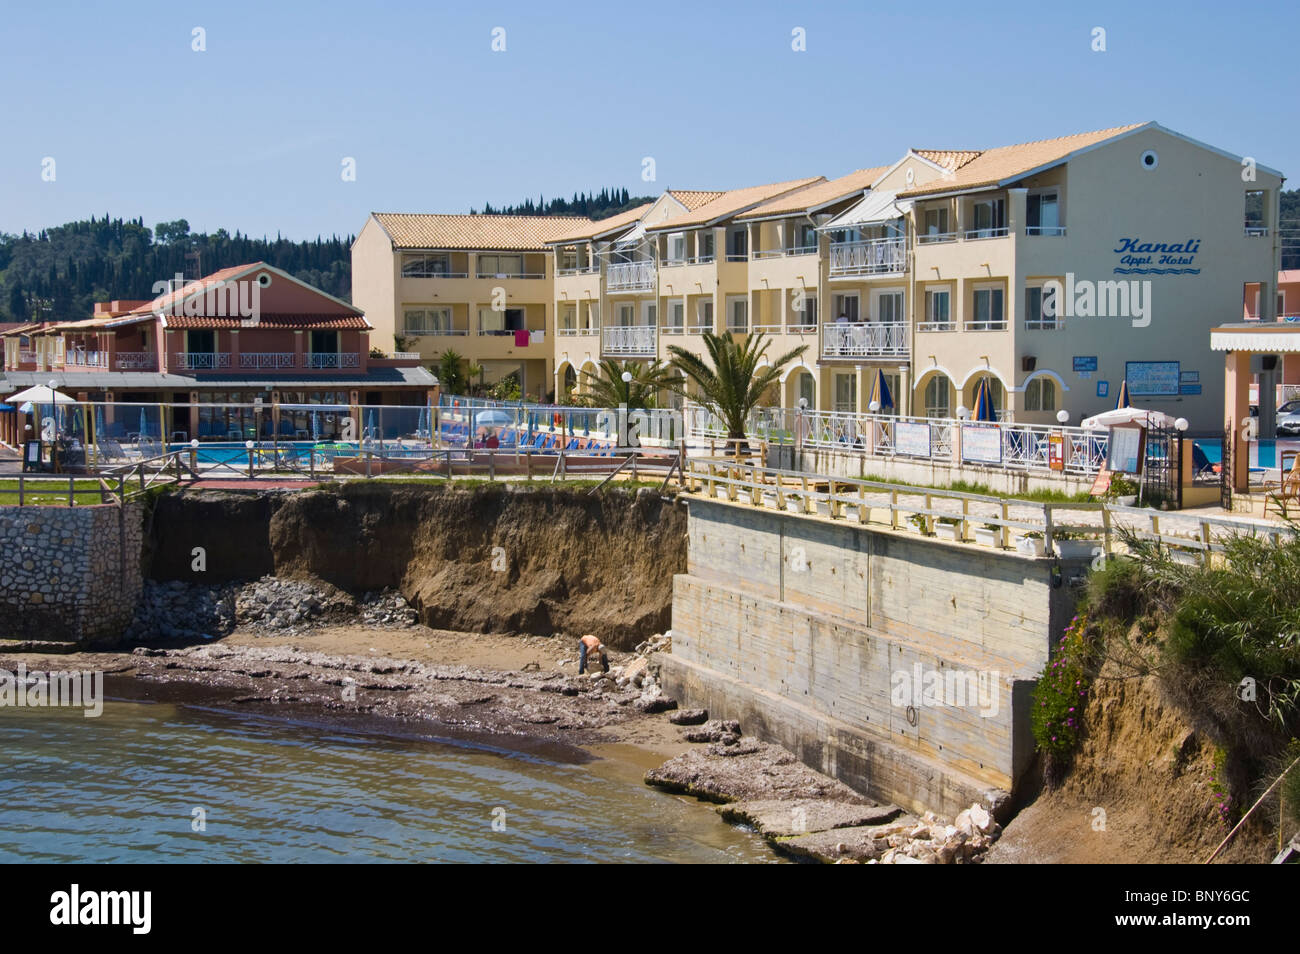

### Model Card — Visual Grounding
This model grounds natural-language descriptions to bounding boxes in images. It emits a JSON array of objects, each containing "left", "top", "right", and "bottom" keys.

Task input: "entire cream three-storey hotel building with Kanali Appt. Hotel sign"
[{"left": 352, "top": 122, "right": 1283, "bottom": 433}]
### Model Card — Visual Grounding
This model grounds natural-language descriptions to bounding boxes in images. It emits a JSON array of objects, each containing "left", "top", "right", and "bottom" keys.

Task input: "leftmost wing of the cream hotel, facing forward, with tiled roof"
[{"left": 352, "top": 212, "right": 589, "bottom": 400}]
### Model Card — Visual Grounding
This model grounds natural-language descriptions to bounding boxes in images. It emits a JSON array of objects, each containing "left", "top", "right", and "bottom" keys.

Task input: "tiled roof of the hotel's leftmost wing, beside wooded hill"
[{"left": 372, "top": 212, "right": 592, "bottom": 252}]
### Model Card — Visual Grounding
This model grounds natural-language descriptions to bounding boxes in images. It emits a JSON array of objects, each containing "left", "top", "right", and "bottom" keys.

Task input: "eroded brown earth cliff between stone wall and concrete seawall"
[{"left": 151, "top": 483, "right": 686, "bottom": 649}]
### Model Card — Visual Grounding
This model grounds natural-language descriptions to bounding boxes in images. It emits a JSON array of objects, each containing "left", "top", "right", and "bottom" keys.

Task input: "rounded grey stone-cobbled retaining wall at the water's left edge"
[{"left": 0, "top": 503, "right": 143, "bottom": 645}]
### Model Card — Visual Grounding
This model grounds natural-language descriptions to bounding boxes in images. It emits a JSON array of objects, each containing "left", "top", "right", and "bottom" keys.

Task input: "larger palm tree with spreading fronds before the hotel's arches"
[{"left": 668, "top": 331, "right": 809, "bottom": 452}]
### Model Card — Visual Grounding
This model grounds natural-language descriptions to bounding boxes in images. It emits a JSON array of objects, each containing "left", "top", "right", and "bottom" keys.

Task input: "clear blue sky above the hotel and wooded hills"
[{"left": 0, "top": 0, "right": 1300, "bottom": 238}]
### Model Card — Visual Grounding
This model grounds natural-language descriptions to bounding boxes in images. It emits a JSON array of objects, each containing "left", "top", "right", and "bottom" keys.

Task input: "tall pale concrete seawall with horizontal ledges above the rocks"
[{"left": 663, "top": 498, "right": 1074, "bottom": 814}]
